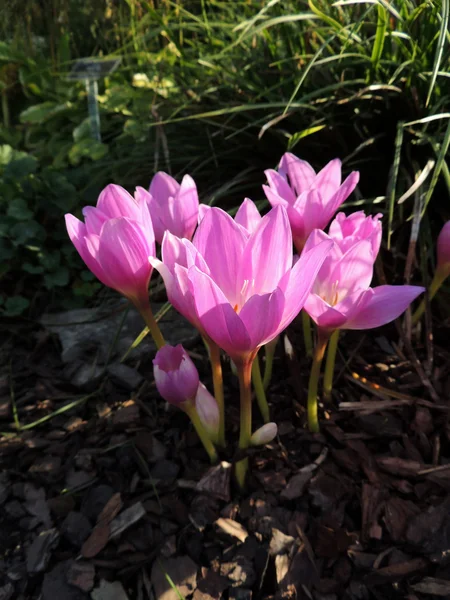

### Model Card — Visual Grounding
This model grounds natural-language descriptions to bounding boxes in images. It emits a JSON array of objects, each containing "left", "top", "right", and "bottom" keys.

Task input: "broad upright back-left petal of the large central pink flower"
[{"left": 193, "top": 208, "right": 247, "bottom": 306}]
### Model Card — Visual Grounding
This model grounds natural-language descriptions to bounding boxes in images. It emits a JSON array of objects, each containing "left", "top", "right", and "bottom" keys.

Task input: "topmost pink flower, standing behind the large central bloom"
[{"left": 263, "top": 152, "right": 359, "bottom": 253}]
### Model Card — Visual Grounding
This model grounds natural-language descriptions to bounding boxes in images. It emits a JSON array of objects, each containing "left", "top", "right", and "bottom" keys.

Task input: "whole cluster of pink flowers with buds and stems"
[{"left": 66, "top": 153, "right": 428, "bottom": 486}]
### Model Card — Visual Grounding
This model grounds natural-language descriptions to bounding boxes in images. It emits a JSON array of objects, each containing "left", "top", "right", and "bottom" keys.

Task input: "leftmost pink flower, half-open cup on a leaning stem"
[{"left": 65, "top": 184, "right": 155, "bottom": 305}]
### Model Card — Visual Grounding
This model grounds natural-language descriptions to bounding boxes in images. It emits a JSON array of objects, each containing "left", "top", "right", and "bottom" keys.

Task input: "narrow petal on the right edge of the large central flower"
[{"left": 279, "top": 241, "right": 333, "bottom": 329}]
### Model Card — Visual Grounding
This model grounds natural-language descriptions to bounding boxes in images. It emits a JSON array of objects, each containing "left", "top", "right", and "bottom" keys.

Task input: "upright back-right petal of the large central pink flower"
[{"left": 238, "top": 206, "right": 292, "bottom": 298}]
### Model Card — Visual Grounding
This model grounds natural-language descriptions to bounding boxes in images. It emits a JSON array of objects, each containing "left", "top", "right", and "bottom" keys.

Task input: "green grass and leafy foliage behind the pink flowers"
[{"left": 0, "top": 0, "right": 450, "bottom": 315}]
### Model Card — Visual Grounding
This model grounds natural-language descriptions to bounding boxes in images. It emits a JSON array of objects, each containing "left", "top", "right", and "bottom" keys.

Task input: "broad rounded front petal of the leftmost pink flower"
[{"left": 98, "top": 218, "right": 152, "bottom": 301}]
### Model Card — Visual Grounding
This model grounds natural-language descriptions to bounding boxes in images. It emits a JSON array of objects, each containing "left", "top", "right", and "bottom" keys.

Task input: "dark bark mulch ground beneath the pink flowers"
[{"left": 0, "top": 312, "right": 450, "bottom": 600}]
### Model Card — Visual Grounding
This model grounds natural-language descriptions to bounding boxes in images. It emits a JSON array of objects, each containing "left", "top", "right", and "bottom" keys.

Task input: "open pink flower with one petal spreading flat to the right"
[{"left": 304, "top": 230, "right": 425, "bottom": 331}]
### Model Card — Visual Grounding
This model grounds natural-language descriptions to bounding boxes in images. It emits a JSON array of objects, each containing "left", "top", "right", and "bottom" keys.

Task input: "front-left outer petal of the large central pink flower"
[{"left": 189, "top": 267, "right": 254, "bottom": 360}]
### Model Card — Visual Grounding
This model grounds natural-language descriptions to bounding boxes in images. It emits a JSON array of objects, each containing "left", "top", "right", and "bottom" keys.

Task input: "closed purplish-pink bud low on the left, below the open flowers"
[{"left": 153, "top": 344, "right": 199, "bottom": 406}]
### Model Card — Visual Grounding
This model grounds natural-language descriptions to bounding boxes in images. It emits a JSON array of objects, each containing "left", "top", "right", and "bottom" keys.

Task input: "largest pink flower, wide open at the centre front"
[{"left": 151, "top": 207, "right": 333, "bottom": 364}]
